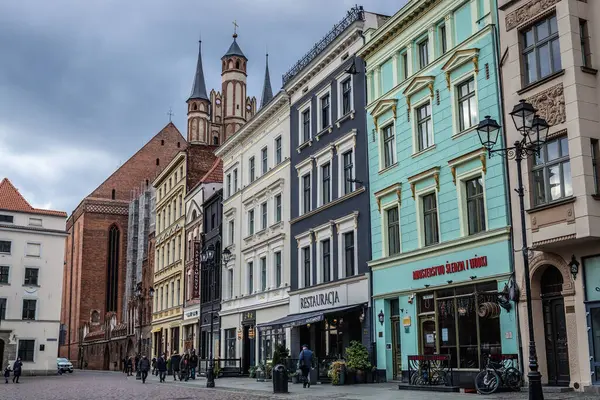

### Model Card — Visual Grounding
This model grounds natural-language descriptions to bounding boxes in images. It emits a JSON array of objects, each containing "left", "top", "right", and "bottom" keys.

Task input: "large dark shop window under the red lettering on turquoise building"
[{"left": 419, "top": 282, "right": 502, "bottom": 369}]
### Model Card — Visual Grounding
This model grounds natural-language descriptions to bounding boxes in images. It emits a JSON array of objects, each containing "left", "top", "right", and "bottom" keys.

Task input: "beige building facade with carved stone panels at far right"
[{"left": 500, "top": 0, "right": 600, "bottom": 390}]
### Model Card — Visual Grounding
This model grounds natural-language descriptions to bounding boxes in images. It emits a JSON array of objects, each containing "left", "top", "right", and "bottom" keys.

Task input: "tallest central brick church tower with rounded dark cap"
[{"left": 221, "top": 29, "right": 256, "bottom": 141}]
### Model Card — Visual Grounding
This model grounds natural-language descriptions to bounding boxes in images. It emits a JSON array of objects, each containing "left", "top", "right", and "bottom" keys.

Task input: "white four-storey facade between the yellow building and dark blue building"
[{"left": 217, "top": 91, "right": 291, "bottom": 372}]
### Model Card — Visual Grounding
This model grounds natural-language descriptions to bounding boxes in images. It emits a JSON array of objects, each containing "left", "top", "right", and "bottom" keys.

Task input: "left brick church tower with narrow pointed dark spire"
[{"left": 187, "top": 41, "right": 212, "bottom": 144}]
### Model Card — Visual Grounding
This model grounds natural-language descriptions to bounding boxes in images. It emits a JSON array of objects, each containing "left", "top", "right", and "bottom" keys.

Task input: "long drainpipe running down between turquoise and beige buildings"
[{"left": 492, "top": 24, "right": 524, "bottom": 371}]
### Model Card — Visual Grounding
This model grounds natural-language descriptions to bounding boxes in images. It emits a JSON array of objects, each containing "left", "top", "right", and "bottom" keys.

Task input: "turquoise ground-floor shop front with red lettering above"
[{"left": 371, "top": 234, "right": 518, "bottom": 388}]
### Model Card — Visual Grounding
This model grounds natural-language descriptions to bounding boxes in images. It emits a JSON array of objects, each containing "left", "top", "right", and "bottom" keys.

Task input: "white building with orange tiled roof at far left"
[{"left": 0, "top": 179, "right": 67, "bottom": 375}]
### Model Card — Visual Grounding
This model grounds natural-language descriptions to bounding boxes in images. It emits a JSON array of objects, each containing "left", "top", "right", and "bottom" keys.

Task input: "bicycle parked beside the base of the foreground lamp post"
[{"left": 475, "top": 357, "right": 523, "bottom": 395}]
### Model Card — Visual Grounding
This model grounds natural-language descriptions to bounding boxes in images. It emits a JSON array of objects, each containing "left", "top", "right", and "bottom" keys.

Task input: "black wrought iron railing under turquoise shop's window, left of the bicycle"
[{"left": 408, "top": 354, "right": 454, "bottom": 386}]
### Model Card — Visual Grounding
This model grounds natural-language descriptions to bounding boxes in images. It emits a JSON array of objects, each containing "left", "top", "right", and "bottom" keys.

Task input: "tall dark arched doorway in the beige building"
[{"left": 540, "top": 266, "right": 571, "bottom": 386}]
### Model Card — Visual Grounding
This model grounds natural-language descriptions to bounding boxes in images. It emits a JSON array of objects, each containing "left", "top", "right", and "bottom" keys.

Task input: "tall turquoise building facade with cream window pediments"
[{"left": 359, "top": 0, "right": 519, "bottom": 386}]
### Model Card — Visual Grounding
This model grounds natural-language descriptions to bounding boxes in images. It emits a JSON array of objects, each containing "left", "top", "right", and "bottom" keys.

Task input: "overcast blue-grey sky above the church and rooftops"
[{"left": 0, "top": 0, "right": 405, "bottom": 213}]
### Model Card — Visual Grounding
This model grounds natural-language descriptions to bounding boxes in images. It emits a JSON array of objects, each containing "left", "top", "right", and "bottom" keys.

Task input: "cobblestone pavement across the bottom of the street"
[{"left": 0, "top": 371, "right": 598, "bottom": 400}]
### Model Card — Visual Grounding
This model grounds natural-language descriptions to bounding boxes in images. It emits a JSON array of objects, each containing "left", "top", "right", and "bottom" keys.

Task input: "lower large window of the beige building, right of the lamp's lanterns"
[{"left": 531, "top": 136, "right": 573, "bottom": 206}]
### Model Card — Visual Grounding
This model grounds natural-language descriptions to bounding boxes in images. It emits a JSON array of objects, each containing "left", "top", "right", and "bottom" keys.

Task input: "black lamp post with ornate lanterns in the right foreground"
[{"left": 477, "top": 100, "right": 549, "bottom": 400}]
